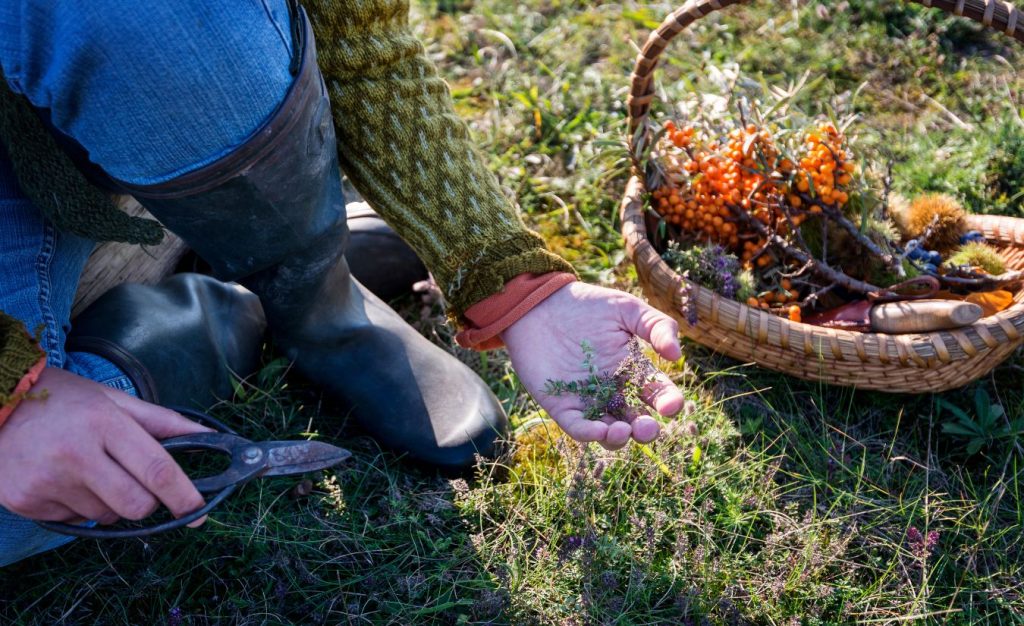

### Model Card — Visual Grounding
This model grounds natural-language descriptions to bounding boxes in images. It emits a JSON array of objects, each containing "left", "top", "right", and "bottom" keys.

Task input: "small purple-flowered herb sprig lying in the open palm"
[{"left": 544, "top": 337, "right": 657, "bottom": 420}]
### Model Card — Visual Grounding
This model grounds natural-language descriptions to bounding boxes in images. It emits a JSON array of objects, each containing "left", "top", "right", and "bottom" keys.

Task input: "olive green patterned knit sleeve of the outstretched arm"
[{"left": 306, "top": 0, "right": 572, "bottom": 319}]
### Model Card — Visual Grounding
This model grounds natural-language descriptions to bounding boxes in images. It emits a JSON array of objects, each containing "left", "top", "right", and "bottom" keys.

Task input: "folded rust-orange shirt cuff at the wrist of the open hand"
[{"left": 455, "top": 272, "right": 577, "bottom": 350}]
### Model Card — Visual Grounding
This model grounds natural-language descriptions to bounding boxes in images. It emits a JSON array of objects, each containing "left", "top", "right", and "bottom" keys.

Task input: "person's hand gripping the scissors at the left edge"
[{"left": 0, "top": 368, "right": 210, "bottom": 527}]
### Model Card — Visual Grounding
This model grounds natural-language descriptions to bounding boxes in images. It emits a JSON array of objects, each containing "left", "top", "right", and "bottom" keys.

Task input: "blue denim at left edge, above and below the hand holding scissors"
[{"left": 0, "top": 142, "right": 135, "bottom": 566}]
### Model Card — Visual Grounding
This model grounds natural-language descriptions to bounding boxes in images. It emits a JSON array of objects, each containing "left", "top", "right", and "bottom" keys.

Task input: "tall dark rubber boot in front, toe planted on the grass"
[{"left": 114, "top": 7, "right": 506, "bottom": 468}]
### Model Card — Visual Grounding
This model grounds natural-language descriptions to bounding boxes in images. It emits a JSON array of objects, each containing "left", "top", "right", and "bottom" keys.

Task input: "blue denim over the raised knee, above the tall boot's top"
[{"left": 0, "top": 0, "right": 292, "bottom": 184}]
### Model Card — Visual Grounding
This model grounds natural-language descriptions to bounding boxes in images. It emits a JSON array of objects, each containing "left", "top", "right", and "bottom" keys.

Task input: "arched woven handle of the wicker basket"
[{"left": 626, "top": 0, "right": 1024, "bottom": 168}]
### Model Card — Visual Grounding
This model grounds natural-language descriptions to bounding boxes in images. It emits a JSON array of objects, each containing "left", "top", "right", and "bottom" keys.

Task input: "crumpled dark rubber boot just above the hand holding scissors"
[{"left": 68, "top": 274, "right": 266, "bottom": 410}]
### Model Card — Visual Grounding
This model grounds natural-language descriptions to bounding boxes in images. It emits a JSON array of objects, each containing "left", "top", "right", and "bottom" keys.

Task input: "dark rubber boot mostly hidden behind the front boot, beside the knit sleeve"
[{"left": 345, "top": 202, "right": 427, "bottom": 302}]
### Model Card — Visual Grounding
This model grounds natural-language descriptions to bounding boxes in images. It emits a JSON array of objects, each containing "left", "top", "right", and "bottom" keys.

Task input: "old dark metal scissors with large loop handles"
[{"left": 36, "top": 408, "right": 352, "bottom": 539}]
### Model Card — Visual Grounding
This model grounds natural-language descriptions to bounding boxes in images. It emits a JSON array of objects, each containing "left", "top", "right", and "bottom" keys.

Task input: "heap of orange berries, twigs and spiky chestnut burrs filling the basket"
[{"left": 648, "top": 105, "right": 1024, "bottom": 321}]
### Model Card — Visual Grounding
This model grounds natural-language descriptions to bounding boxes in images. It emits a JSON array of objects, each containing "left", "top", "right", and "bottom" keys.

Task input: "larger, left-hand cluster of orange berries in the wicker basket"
[{"left": 652, "top": 121, "right": 793, "bottom": 252}]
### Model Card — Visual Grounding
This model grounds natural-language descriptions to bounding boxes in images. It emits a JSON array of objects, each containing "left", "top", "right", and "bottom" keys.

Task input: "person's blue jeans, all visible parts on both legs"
[{"left": 0, "top": 0, "right": 292, "bottom": 566}]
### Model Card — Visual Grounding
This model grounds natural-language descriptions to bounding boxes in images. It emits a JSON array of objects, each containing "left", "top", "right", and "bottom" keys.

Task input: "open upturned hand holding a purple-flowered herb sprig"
[{"left": 502, "top": 283, "right": 684, "bottom": 450}]
